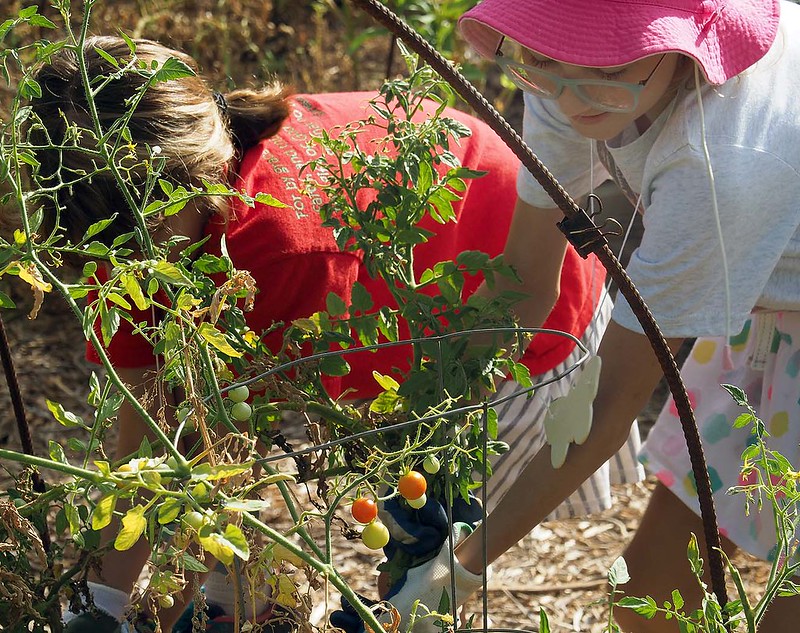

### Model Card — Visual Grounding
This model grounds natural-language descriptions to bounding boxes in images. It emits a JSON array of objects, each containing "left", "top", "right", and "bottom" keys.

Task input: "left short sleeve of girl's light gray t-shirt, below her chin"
[{"left": 517, "top": 94, "right": 609, "bottom": 209}]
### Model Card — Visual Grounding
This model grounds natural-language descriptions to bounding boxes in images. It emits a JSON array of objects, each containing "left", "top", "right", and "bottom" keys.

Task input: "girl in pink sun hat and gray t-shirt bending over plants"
[{"left": 378, "top": 0, "right": 800, "bottom": 633}]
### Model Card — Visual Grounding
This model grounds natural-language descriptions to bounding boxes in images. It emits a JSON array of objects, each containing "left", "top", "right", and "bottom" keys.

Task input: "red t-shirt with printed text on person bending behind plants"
[{"left": 87, "top": 93, "right": 605, "bottom": 397}]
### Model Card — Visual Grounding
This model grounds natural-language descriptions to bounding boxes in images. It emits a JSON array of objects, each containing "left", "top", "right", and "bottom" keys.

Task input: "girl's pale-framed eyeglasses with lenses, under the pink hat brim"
[{"left": 494, "top": 37, "right": 666, "bottom": 112}]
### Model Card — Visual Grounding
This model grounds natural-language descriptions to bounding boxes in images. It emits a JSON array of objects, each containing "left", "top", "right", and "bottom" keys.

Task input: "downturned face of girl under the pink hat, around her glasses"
[{"left": 524, "top": 51, "right": 680, "bottom": 140}]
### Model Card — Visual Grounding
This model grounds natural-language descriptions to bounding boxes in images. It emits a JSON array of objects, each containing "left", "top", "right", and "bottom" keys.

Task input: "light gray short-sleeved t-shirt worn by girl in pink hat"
[{"left": 518, "top": 2, "right": 800, "bottom": 337}]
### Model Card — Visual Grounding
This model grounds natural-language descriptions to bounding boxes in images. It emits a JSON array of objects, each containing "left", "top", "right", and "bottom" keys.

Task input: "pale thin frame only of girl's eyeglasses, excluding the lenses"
[{"left": 494, "top": 35, "right": 667, "bottom": 113}]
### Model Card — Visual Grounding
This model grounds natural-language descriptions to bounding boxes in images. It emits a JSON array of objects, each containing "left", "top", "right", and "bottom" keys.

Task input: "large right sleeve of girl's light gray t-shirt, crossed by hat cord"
[{"left": 613, "top": 145, "right": 800, "bottom": 338}]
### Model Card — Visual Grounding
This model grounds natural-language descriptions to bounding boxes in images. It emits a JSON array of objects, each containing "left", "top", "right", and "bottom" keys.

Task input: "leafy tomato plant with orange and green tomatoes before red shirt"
[{"left": 0, "top": 12, "right": 528, "bottom": 633}]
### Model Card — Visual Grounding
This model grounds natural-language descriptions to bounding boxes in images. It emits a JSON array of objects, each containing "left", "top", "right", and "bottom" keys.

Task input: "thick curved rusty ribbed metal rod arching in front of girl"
[{"left": 351, "top": 0, "right": 728, "bottom": 606}]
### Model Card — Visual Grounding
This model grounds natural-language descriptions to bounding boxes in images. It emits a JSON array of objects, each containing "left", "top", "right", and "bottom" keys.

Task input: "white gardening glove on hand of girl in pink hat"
[{"left": 385, "top": 524, "right": 483, "bottom": 633}]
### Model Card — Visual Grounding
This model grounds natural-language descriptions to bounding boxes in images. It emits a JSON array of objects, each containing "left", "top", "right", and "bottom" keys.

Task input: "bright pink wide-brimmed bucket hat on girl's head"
[{"left": 459, "top": 0, "right": 780, "bottom": 84}]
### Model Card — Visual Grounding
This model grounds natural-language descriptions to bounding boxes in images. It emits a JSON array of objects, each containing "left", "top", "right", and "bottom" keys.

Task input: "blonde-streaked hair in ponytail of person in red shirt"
[{"left": 29, "top": 36, "right": 289, "bottom": 244}]
